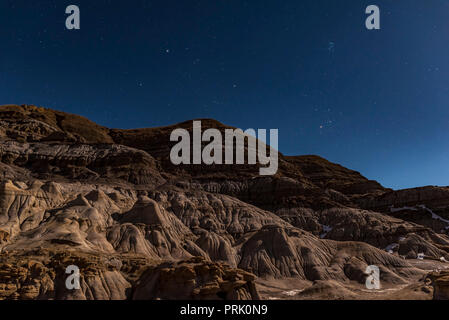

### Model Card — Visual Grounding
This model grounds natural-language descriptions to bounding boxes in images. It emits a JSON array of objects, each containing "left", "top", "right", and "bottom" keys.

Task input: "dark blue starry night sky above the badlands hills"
[{"left": 0, "top": 0, "right": 449, "bottom": 188}]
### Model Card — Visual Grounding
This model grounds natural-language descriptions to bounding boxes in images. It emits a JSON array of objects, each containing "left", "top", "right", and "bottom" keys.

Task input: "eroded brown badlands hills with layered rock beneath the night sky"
[{"left": 0, "top": 105, "right": 449, "bottom": 300}]
